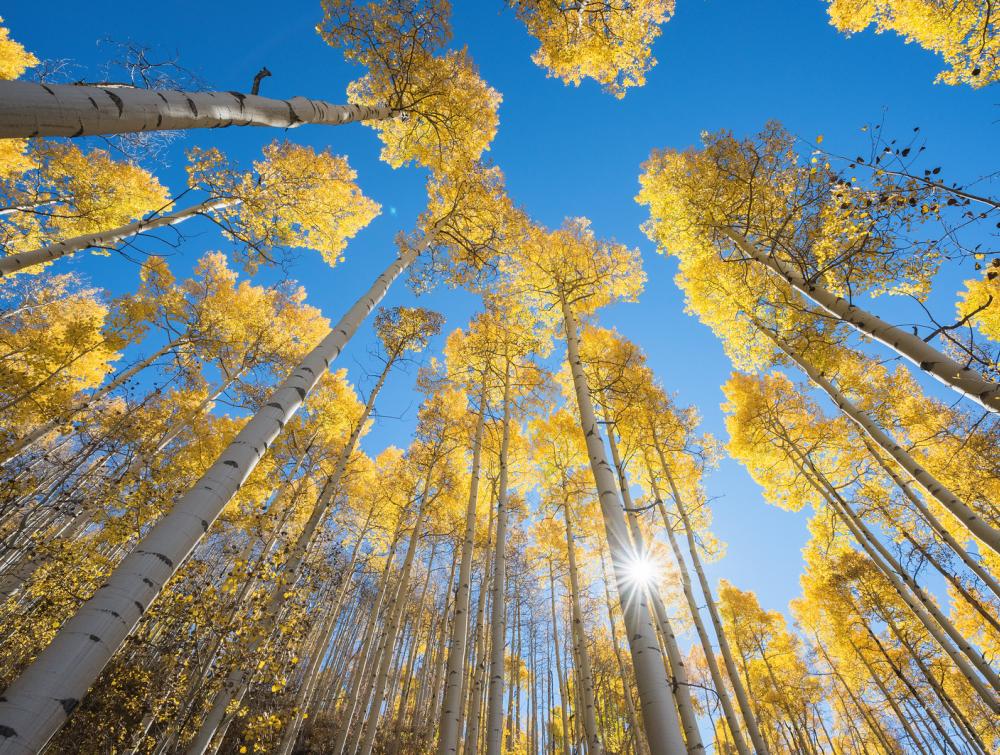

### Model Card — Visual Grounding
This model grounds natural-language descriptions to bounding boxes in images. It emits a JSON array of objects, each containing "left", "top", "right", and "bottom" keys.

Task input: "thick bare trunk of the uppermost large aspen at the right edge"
[{"left": 721, "top": 228, "right": 1000, "bottom": 412}]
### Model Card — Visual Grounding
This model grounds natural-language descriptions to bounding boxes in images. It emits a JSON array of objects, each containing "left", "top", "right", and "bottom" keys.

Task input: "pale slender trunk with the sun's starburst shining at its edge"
[{"left": 560, "top": 296, "right": 685, "bottom": 755}]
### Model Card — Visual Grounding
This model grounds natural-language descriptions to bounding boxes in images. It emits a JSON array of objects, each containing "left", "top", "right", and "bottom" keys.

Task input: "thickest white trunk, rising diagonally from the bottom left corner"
[{"left": 0, "top": 249, "right": 418, "bottom": 754}]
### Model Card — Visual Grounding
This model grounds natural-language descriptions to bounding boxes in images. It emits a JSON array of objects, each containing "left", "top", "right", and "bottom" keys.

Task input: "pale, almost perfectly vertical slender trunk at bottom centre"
[{"left": 486, "top": 359, "right": 510, "bottom": 755}]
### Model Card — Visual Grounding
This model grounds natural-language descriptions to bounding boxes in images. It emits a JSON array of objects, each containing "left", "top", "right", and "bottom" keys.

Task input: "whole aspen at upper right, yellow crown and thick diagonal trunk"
[{"left": 637, "top": 124, "right": 1000, "bottom": 412}]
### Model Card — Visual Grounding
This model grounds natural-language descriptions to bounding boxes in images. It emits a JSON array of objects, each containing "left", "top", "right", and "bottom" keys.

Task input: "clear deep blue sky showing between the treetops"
[{"left": 9, "top": 0, "right": 1000, "bottom": 611}]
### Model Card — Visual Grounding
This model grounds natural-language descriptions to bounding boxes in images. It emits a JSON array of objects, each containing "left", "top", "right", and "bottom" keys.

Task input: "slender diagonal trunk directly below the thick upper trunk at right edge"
[{"left": 765, "top": 330, "right": 1000, "bottom": 554}]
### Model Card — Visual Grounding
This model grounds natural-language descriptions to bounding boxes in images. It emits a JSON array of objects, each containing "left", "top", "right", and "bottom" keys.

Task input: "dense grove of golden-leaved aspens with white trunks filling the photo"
[{"left": 0, "top": 0, "right": 1000, "bottom": 755}]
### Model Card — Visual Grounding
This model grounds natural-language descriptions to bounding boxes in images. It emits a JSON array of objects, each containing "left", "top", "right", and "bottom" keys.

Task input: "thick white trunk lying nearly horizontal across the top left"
[{"left": 0, "top": 81, "right": 393, "bottom": 138}]
